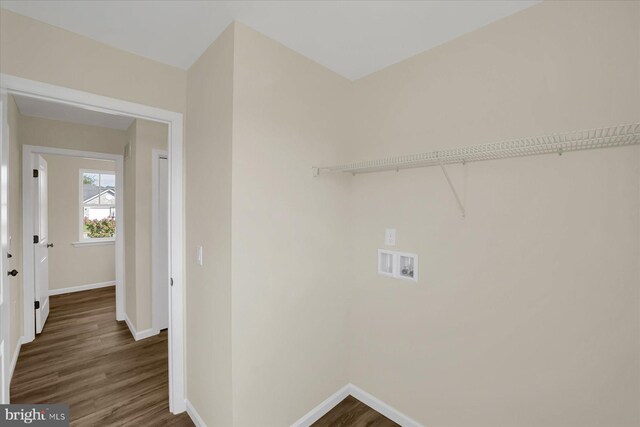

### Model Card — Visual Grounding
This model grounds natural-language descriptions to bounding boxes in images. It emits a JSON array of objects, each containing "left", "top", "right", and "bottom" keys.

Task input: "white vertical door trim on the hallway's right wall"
[{"left": 151, "top": 148, "right": 171, "bottom": 335}]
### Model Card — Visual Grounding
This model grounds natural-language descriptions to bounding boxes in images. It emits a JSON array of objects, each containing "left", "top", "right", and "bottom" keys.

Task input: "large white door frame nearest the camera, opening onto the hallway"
[{"left": 0, "top": 74, "right": 186, "bottom": 414}]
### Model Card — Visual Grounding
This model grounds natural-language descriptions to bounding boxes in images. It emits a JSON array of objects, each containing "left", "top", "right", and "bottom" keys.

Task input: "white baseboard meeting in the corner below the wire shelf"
[{"left": 288, "top": 384, "right": 423, "bottom": 427}]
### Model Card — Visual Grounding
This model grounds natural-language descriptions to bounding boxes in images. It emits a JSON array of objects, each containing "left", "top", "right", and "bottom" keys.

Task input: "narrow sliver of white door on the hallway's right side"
[{"left": 157, "top": 157, "right": 169, "bottom": 330}]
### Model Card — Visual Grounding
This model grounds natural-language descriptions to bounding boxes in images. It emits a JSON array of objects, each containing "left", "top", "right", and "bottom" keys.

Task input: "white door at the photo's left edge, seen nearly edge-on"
[{"left": 0, "top": 94, "right": 12, "bottom": 404}]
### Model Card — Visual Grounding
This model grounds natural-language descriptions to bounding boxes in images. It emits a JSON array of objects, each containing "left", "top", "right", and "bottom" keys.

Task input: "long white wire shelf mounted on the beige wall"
[{"left": 313, "top": 123, "right": 640, "bottom": 176}]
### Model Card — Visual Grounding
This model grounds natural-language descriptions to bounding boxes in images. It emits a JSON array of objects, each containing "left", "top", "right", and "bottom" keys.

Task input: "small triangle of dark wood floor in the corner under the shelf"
[{"left": 312, "top": 396, "right": 400, "bottom": 427}]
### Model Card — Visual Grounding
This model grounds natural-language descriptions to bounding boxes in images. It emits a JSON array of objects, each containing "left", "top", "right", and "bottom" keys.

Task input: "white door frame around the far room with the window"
[{"left": 22, "top": 145, "right": 125, "bottom": 334}]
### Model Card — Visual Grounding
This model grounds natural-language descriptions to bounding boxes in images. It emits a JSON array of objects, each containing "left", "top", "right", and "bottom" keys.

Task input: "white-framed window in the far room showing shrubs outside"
[{"left": 80, "top": 170, "right": 116, "bottom": 242}]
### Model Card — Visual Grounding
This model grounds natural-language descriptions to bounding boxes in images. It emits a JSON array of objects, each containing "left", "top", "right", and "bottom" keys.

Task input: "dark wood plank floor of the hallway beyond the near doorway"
[{"left": 11, "top": 287, "right": 193, "bottom": 426}]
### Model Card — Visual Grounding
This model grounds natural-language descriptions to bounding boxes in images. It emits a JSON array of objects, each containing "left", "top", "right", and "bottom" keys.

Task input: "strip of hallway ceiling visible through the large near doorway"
[{"left": 14, "top": 95, "right": 134, "bottom": 130}]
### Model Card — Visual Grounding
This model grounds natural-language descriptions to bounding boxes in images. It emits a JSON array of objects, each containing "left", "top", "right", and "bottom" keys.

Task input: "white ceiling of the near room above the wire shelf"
[{"left": 2, "top": 0, "right": 539, "bottom": 80}]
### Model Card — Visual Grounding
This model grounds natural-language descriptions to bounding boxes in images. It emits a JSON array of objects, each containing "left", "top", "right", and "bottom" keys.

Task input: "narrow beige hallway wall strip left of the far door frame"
[{"left": 7, "top": 95, "right": 23, "bottom": 360}]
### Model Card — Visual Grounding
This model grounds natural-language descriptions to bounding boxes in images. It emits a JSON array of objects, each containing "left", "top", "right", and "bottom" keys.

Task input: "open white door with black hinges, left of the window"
[{"left": 33, "top": 154, "right": 53, "bottom": 334}]
